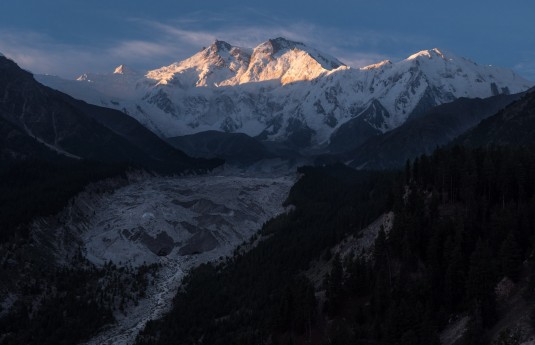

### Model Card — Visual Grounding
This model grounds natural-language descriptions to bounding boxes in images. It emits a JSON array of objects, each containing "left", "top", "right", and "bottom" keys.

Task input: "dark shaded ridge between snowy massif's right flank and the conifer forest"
[{"left": 342, "top": 94, "right": 522, "bottom": 169}]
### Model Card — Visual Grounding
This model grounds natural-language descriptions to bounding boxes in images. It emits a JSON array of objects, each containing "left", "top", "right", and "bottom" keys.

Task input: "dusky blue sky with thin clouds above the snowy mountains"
[{"left": 0, "top": 0, "right": 535, "bottom": 80}]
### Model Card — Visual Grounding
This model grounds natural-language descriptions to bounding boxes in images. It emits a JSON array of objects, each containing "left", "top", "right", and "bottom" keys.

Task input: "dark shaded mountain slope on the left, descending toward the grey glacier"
[{"left": 0, "top": 57, "right": 220, "bottom": 170}]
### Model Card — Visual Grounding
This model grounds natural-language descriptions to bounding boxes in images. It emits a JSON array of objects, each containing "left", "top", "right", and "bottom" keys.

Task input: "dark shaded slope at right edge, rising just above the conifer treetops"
[{"left": 455, "top": 89, "right": 535, "bottom": 147}]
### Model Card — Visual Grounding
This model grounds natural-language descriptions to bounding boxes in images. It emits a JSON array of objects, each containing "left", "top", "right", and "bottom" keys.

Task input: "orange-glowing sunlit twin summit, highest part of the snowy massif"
[{"left": 143, "top": 37, "right": 344, "bottom": 88}]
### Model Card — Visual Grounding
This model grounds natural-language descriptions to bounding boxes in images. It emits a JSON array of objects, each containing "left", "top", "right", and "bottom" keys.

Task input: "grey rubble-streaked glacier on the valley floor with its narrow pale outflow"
[{"left": 35, "top": 174, "right": 296, "bottom": 345}]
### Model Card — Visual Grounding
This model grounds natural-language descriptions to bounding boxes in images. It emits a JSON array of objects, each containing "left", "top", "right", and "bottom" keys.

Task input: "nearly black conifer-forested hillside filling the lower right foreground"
[{"left": 138, "top": 147, "right": 535, "bottom": 344}]
